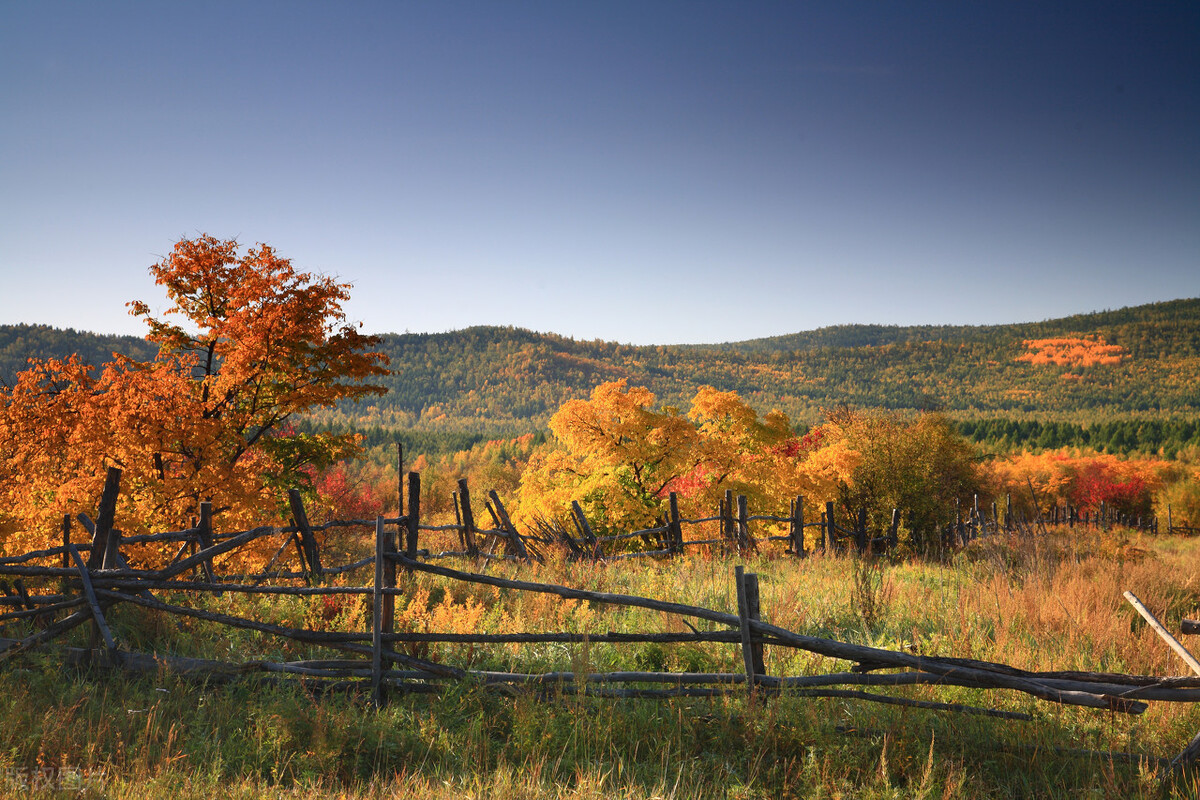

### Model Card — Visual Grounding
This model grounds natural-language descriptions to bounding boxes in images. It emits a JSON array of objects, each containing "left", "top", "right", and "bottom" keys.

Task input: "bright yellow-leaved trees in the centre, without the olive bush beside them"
[{"left": 518, "top": 380, "right": 805, "bottom": 533}]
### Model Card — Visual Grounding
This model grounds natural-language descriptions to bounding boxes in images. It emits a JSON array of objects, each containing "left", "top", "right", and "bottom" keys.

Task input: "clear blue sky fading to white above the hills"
[{"left": 0, "top": 0, "right": 1200, "bottom": 343}]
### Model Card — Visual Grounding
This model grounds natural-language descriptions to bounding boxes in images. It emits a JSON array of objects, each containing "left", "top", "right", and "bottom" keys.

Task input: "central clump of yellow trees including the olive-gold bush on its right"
[{"left": 520, "top": 381, "right": 979, "bottom": 546}]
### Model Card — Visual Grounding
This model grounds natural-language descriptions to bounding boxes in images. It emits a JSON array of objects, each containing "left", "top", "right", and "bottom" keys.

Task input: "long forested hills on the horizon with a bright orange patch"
[{"left": 0, "top": 299, "right": 1200, "bottom": 450}]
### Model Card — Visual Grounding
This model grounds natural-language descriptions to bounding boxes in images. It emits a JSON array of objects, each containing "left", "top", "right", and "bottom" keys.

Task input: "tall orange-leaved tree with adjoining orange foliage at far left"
[{"left": 0, "top": 235, "right": 386, "bottom": 563}]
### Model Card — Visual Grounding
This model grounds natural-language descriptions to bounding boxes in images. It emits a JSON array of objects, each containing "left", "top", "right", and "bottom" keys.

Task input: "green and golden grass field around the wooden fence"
[{"left": 0, "top": 533, "right": 1200, "bottom": 799}]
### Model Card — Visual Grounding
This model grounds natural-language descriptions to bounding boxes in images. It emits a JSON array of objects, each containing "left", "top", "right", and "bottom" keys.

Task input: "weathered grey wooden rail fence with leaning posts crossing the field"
[{"left": 0, "top": 470, "right": 1200, "bottom": 768}]
